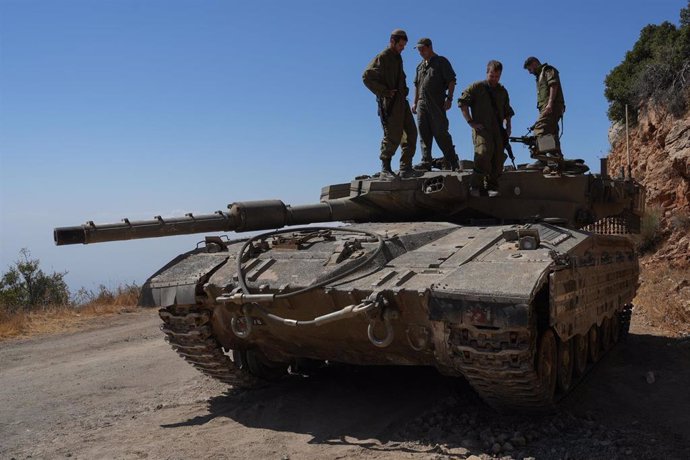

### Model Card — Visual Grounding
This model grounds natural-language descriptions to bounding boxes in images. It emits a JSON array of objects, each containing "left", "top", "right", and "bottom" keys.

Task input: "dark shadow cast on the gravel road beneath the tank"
[{"left": 160, "top": 335, "right": 690, "bottom": 458}]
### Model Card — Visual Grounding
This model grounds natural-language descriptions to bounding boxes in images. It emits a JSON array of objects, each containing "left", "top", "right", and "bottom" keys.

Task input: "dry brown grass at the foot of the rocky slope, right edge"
[{"left": 633, "top": 261, "right": 690, "bottom": 334}]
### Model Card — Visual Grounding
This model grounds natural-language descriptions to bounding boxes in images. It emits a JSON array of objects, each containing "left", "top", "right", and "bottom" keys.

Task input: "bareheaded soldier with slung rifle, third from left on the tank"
[{"left": 458, "top": 61, "right": 515, "bottom": 197}]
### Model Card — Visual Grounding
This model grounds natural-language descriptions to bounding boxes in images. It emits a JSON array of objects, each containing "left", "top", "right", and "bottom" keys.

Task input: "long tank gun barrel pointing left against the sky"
[{"left": 53, "top": 200, "right": 371, "bottom": 246}]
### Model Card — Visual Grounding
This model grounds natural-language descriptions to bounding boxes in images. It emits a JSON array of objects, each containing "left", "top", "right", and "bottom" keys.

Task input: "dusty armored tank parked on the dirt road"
[{"left": 54, "top": 159, "right": 644, "bottom": 409}]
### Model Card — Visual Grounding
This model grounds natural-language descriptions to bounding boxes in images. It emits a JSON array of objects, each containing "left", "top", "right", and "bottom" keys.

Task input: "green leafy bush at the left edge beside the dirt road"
[{"left": 0, "top": 248, "right": 70, "bottom": 312}]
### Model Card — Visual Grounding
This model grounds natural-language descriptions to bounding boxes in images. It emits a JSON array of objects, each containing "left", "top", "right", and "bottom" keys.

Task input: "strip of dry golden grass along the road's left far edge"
[{"left": 0, "top": 286, "right": 139, "bottom": 341}]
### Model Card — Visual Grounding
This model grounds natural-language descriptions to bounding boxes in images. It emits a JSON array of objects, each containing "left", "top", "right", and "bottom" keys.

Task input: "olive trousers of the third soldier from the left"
[{"left": 471, "top": 128, "right": 508, "bottom": 190}]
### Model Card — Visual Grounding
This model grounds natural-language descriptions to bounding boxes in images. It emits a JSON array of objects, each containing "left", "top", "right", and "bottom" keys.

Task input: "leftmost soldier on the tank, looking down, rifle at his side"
[{"left": 362, "top": 29, "right": 417, "bottom": 179}]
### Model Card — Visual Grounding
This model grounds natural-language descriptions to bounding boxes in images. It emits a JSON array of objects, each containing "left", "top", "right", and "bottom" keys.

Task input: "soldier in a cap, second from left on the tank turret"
[{"left": 412, "top": 38, "right": 459, "bottom": 170}]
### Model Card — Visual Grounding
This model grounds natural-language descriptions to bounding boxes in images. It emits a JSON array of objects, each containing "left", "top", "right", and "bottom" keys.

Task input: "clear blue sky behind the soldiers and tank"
[{"left": 0, "top": 0, "right": 687, "bottom": 292}]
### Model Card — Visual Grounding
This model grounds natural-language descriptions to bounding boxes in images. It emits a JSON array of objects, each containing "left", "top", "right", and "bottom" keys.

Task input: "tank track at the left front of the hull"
[{"left": 158, "top": 305, "right": 261, "bottom": 389}]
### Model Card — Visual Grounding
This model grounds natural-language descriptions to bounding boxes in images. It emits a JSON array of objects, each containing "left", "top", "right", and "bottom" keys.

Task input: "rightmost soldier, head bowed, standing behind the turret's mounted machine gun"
[{"left": 524, "top": 56, "right": 565, "bottom": 153}]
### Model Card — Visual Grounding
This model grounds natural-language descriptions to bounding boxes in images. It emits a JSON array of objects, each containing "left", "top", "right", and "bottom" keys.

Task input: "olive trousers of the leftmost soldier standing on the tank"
[{"left": 380, "top": 99, "right": 417, "bottom": 168}]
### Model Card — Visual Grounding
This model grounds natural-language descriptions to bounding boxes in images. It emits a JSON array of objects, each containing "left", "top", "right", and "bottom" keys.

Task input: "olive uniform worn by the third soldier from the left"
[{"left": 459, "top": 80, "right": 515, "bottom": 190}]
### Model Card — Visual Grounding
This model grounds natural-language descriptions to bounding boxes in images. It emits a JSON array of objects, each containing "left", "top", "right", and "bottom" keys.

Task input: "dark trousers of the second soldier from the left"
[{"left": 417, "top": 100, "right": 457, "bottom": 166}]
